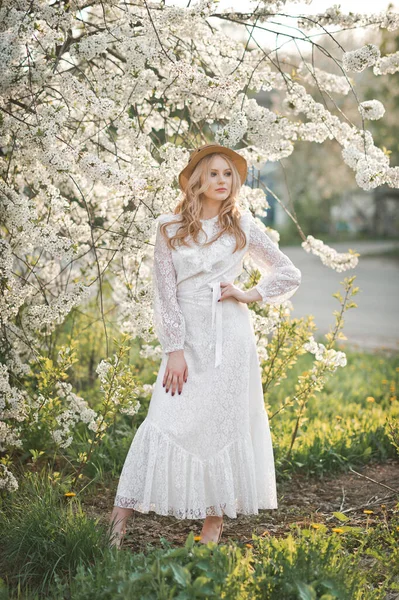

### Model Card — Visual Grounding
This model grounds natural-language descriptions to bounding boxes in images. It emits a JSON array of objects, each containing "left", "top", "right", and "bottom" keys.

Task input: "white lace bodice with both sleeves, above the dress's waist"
[{"left": 153, "top": 211, "right": 301, "bottom": 353}]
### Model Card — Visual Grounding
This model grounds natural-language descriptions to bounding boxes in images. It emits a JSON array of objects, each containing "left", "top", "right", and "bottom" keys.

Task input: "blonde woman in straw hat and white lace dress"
[{"left": 110, "top": 144, "right": 301, "bottom": 547}]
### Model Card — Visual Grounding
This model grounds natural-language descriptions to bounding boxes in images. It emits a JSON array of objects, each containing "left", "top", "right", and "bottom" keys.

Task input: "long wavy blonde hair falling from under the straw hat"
[{"left": 160, "top": 152, "right": 246, "bottom": 252}]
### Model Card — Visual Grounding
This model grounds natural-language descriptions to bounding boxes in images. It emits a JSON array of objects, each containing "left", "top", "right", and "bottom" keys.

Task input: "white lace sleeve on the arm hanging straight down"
[{"left": 153, "top": 215, "right": 186, "bottom": 353}]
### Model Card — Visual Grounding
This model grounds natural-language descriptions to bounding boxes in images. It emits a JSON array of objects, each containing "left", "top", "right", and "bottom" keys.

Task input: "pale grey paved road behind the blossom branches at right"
[{"left": 281, "top": 241, "right": 399, "bottom": 351}]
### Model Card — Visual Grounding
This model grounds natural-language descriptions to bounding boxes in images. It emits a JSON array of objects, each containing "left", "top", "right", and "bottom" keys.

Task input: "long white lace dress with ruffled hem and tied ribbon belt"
[{"left": 114, "top": 211, "right": 301, "bottom": 519}]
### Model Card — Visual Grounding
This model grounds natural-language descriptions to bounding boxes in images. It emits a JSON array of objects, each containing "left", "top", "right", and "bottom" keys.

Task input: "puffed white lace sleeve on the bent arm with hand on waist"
[{"left": 249, "top": 215, "right": 302, "bottom": 305}]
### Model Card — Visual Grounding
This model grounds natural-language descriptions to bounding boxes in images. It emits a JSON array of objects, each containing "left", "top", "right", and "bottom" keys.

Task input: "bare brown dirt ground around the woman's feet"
[{"left": 84, "top": 459, "right": 399, "bottom": 552}]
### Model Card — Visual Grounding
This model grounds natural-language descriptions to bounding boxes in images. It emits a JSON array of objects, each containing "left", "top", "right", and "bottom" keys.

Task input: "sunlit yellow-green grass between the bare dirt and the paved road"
[{"left": 266, "top": 350, "right": 399, "bottom": 477}]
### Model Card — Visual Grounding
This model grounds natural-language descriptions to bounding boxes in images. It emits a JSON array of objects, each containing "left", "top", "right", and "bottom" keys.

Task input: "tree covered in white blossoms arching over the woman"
[{"left": 0, "top": 0, "right": 399, "bottom": 489}]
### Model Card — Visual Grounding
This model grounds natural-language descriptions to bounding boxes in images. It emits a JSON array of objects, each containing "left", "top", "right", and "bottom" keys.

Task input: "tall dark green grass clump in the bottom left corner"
[{"left": 0, "top": 471, "right": 108, "bottom": 597}]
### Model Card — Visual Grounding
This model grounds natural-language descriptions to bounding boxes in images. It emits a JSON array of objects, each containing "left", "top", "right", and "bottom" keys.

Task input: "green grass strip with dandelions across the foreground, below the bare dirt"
[{"left": 0, "top": 474, "right": 399, "bottom": 600}]
